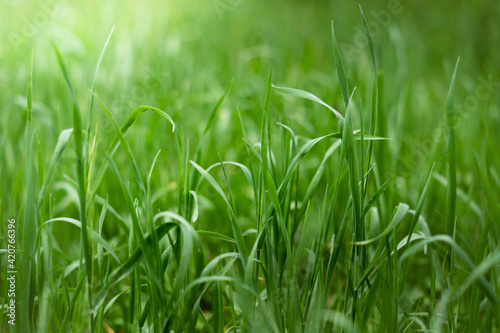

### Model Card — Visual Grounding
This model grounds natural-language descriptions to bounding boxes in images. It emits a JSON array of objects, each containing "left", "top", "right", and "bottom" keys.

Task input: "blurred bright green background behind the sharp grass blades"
[{"left": 0, "top": 0, "right": 500, "bottom": 230}]
